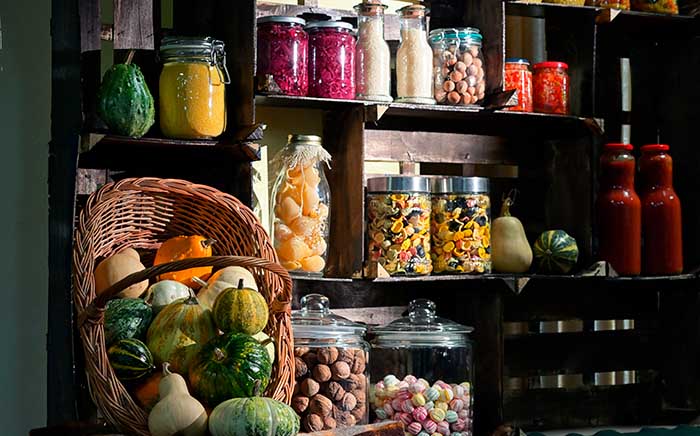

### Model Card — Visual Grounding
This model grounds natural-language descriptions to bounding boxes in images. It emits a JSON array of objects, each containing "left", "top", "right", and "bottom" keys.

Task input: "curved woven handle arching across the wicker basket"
[{"left": 78, "top": 256, "right": 292, "bottom": 324}]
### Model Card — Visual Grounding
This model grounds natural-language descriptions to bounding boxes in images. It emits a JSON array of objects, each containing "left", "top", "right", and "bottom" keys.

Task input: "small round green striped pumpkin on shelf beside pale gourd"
[{"left": 533, "top": 230, "right": 578, "bottom": 274}]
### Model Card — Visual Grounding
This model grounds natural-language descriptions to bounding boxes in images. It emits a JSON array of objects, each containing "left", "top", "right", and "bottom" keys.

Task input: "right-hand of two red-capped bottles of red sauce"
[{"left": 639, "top": 144, "right": 683, "bottom": 275}]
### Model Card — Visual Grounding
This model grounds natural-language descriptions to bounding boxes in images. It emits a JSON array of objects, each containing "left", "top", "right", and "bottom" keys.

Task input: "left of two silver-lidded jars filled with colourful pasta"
[{"left": 367, "top": 176, "right": 433, "bottom": 276}]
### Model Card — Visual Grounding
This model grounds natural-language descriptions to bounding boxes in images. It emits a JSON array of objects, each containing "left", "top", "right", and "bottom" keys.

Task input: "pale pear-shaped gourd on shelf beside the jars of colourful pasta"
[{"left": 491, "top": 198, "right": 532, "bottom": 273}]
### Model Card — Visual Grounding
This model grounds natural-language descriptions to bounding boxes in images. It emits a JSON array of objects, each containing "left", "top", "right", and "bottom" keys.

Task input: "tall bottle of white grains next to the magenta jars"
[{"left": 355, "top": 0, "right": 393, "bottom": 102}]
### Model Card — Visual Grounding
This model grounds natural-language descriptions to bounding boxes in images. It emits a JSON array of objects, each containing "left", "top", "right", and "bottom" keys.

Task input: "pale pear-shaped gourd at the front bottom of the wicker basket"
[{"left": 148, "top": 362, "right": 207, "bottom": 436}]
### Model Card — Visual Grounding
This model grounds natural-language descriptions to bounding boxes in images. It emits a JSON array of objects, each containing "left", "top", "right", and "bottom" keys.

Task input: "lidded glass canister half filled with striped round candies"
[{"left": 370, "top": 299, "right": 474, "bottom": 436}]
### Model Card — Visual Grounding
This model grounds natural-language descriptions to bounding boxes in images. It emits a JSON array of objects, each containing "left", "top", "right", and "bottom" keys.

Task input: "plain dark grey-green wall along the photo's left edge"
[{"left": 0, "top": 0, "right": 51, "bottom": 436}]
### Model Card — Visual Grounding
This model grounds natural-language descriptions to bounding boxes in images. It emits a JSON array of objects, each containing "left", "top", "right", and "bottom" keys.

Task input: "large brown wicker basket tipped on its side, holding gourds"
[{"left": 73, "top": 178, "right": 294, "bottom": 436}]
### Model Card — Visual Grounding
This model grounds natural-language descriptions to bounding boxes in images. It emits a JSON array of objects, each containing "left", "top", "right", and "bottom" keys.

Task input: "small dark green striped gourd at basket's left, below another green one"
[{"left": 107, "top": 338, "right": 155, "bottom": 381}]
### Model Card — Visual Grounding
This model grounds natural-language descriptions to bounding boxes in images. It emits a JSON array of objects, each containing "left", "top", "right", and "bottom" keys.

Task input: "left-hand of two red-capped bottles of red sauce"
[{"left": 597, "top": 144, "right": 642, "bottom": 276}]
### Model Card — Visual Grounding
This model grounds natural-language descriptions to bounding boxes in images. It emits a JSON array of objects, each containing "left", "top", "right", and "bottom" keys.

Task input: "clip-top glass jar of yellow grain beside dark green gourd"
[{"left": 159, "top": 36, "right": 231, "bottom": 139}]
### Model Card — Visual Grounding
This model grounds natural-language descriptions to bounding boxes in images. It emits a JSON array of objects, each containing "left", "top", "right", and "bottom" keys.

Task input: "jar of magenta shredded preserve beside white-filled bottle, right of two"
[{"left": 306, "top": 21, "right": 355, "bottom": 100}]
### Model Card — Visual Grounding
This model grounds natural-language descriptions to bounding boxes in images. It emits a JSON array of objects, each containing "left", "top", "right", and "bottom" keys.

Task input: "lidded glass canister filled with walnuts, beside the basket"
[{"left": 292, "top": 294, "right": 369, "bottom": 432}]
